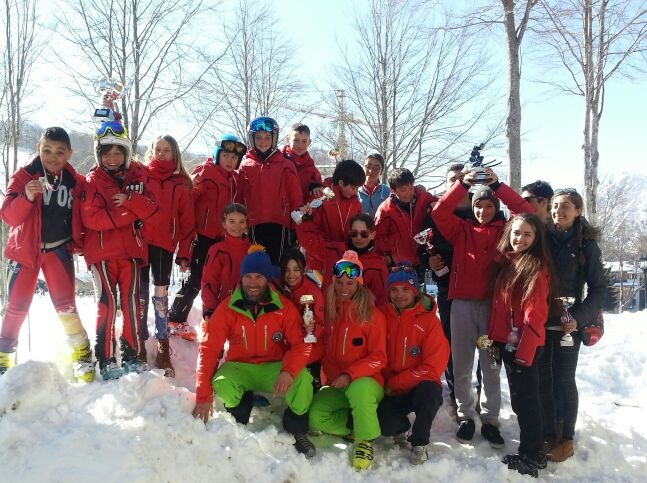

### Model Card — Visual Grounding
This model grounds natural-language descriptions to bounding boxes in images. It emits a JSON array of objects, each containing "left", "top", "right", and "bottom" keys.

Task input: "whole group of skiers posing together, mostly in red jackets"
[{"left": 0, "top": 117, "right": 606, "bottom": 476}]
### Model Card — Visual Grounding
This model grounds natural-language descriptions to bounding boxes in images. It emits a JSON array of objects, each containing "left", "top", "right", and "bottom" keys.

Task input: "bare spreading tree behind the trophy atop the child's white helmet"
[{"left": 53, "top": 0, "right": 222, "bottom": 147}]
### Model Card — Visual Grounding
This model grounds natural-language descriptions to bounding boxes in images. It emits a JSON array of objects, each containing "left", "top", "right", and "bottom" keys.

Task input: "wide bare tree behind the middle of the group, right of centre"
[{"left": 329, "top": 0, "right": 498, "bottom": 183}]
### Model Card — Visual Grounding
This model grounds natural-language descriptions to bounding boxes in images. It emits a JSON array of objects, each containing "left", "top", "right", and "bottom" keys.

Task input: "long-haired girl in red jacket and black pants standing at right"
[{"left": 488, "top": 213, "right": 552, "bottom": 478}]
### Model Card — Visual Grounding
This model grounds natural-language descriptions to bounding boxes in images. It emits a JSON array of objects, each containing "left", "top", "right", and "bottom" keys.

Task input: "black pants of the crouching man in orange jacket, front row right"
[{"left": 377, "top": 381, "right": 443, "bottom": 446}]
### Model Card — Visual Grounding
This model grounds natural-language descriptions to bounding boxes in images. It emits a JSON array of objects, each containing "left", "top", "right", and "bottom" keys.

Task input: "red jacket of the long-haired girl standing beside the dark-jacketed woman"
[{"left": 488, "top": 267, "right": 550, "bottom": 366}]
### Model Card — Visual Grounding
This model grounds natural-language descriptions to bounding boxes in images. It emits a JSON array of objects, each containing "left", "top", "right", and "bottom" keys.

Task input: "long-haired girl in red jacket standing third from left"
[{"left": 139, "top": 135, "right": 195, "bottom": 377}]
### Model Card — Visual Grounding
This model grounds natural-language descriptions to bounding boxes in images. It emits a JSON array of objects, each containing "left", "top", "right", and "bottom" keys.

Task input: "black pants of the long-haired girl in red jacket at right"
[{"left": 499, "top": 344, "right": 544, "bottom": 458}]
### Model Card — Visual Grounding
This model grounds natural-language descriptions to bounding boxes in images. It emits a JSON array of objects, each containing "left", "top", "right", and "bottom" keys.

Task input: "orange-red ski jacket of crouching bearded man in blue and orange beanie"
[{"left": 195, "top": 286, "right": 312, "bottom": 404}]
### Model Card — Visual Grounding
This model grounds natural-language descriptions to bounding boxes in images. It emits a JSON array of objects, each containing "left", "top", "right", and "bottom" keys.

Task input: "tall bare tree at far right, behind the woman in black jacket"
[{"left": 542, "top": 0, "right": 647, "bottom": 223}]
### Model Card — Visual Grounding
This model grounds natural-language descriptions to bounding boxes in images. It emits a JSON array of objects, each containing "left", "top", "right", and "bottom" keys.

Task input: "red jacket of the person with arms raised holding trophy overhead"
[{"left": 431, "top": 183, "right": 535, "bottom": 300}]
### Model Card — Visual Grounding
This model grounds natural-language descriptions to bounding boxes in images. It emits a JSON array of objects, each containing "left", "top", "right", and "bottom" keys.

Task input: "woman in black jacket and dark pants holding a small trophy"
[{"left": 539, "top": 188, "right": 607, "bottom": 462}]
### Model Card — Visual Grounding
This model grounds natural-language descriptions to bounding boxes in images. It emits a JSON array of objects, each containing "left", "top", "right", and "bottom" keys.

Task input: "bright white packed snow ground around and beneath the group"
[{"left": 0, "top": 296, "right": 647, "bottom": 483}]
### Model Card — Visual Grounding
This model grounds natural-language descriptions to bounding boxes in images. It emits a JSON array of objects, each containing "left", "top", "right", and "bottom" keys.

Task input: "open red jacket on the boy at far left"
[{"left": 0, "top": 157, "right": 85, "bottom": 270}]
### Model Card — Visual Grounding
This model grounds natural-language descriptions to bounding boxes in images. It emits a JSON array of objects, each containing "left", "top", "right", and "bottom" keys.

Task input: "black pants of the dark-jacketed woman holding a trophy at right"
[{"left": 539, "top": 330, "right": 582, "bottom": 439}]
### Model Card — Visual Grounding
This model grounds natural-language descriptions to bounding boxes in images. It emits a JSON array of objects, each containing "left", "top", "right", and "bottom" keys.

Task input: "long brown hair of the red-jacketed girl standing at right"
[{"left": 496, "top": 213, "right": 555, "bottom": 304}]
